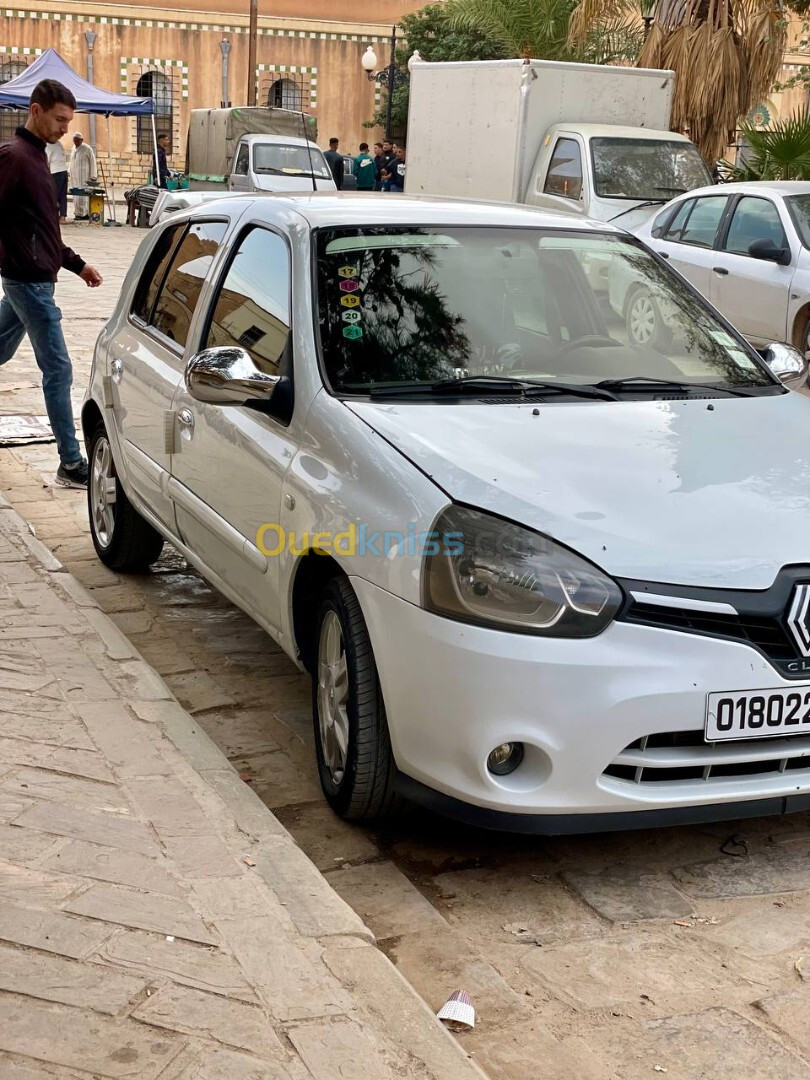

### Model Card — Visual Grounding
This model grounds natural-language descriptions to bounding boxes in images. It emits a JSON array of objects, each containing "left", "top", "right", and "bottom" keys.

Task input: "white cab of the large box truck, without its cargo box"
[{"left": 524, "top": 123, "right": 712, "bottom": 230}]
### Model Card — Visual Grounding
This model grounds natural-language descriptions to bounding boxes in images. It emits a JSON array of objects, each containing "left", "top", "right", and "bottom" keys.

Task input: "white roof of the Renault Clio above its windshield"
[{"left": 182, "top": 191, "right": 623, "bottom": 234}]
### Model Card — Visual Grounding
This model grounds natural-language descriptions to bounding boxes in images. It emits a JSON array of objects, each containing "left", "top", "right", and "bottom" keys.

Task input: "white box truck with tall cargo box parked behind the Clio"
[{"left": 405, "top": 60, "right": 712, "bottom": 229}]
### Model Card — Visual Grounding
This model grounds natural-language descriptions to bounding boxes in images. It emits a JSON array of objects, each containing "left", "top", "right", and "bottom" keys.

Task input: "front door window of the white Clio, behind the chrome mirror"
[{"left": 205, "top": 229, "right": 289, "bottom": 375}]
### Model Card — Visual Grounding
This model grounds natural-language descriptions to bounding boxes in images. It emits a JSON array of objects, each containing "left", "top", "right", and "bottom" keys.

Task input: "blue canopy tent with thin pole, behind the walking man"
[{"left": 0, "top": 49, "right": 158, "bottom": 220}]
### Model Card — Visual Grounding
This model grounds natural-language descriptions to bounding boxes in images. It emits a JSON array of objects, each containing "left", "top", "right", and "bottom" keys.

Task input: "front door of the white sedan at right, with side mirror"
[{"left": 710, "top": 195, "right": 796, "bottom": 347}]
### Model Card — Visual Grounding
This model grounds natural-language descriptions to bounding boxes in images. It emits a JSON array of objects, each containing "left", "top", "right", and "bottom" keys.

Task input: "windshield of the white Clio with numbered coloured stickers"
[{"left": 316, "top": 226, "right": 774, "bottom": 393}]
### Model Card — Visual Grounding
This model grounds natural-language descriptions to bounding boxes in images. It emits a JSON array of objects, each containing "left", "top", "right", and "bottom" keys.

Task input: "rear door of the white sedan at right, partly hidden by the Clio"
[{"left": 650, "top": 195, "right": 728, "bottom": 299}]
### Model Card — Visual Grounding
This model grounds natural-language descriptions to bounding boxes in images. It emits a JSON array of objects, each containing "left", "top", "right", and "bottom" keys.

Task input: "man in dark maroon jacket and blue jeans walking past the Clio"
[{"left": 0, "top": 79, "right": 102, "bottom": 487}]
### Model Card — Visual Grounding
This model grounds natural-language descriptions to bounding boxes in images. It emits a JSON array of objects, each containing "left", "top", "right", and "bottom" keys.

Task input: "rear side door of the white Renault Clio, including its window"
[{"left": 108, "top": 219, "right": 228, "bottom": 531}]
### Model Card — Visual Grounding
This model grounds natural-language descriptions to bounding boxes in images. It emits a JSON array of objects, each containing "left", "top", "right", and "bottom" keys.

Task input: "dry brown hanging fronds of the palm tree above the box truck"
[{"left": 565, "top": 0, "right": 786, "bottom": 164}]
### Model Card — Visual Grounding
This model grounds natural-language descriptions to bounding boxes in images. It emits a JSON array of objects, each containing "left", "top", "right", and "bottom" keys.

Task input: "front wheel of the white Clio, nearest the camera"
[{"left": 312, "top": 578, "right": 395, "bottom": 821}]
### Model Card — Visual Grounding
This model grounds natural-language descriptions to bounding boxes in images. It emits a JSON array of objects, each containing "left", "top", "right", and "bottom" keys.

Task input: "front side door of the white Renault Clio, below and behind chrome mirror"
[{"left": 170, "top": 226, "right": 296, "bottom": 627}]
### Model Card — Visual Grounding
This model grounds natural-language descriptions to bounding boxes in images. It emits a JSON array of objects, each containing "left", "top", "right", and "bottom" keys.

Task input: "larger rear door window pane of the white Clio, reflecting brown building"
[{"left": 151, "top": 221, "right": 228, "bottom": 346}]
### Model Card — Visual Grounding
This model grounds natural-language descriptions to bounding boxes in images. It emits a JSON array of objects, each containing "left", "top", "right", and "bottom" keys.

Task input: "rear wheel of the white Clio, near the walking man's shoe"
[{"left": 87, "top": 423, "right": 163, "bottom": 570}]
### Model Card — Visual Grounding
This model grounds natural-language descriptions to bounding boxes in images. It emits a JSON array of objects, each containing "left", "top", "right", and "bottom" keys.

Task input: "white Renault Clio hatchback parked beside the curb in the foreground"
[{"left": 82, "top": 195, "right": 810, "bottom": 832}]
